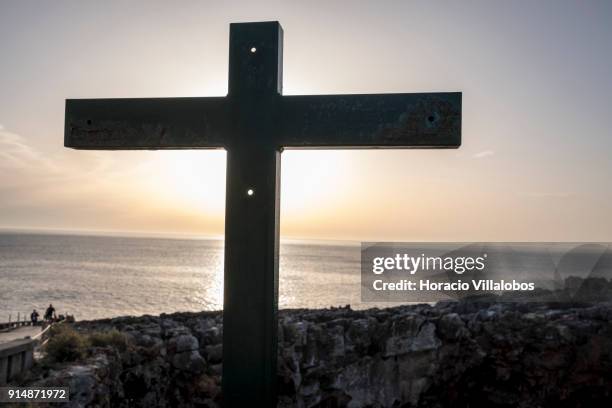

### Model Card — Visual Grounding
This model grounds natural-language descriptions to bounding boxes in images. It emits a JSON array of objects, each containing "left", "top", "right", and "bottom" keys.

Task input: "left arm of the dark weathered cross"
[{"left": 64, "top": 98, "right": 229, "bottom": 150}]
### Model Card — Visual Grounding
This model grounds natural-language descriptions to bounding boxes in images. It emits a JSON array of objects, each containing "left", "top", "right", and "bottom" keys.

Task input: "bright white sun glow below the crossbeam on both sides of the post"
[{"left": 134, "top": 150, "right": 350, "bottom": 223}]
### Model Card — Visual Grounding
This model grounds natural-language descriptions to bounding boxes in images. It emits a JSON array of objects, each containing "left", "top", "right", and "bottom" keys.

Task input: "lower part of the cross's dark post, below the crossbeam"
[{"left": 222, "top": 145, "right": 280, "bottom": 407}]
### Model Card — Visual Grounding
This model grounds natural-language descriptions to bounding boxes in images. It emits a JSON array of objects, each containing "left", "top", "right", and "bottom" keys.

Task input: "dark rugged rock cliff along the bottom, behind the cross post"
[{"left": 31, "top": 302, "right": 612, "bottom": 407}]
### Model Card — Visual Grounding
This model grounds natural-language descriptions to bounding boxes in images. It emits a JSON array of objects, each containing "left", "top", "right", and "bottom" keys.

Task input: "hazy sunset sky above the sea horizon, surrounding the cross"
[{"left": 0, "top": 0, "right": 612, "bottom": 241}]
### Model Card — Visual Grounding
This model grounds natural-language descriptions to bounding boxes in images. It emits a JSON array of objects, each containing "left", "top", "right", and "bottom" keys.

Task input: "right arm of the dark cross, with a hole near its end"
[{"left": 278, "top": 93, "right": 461, "bottom": 148}]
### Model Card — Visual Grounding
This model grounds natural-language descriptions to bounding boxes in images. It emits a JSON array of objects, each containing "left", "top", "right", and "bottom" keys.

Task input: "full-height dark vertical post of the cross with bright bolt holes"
[{"left": 222, "top": 23, "right": 283, "bottom": 407}]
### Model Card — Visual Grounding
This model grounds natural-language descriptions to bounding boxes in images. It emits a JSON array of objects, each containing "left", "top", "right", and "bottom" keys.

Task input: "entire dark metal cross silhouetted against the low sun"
[{"left": 65, "top": 22, "right": 461, "bottom": 407}]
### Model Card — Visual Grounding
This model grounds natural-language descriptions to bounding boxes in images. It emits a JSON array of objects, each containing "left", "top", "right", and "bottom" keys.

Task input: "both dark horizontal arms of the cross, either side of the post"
[{"left": 65, "top": 93, "right": 461, "bottom": 150}]
